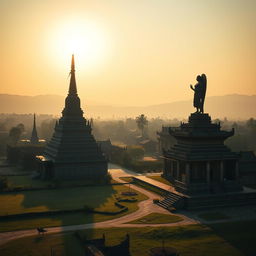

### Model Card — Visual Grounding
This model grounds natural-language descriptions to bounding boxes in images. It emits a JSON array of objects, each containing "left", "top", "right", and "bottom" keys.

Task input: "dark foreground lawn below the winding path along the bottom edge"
[{"left": 0, "top": 221, "right": 256, "bottom": 256}]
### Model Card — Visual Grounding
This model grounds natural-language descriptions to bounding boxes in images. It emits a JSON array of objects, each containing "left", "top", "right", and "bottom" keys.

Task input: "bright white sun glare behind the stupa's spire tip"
[{"left": 51, "top": 20, "right": 107, "bottom": 69}]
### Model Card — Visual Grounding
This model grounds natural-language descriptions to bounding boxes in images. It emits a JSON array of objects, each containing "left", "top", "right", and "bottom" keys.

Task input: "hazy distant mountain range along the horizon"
[{"left": 0, "top": 94, "right": 256, "bottom": 120}]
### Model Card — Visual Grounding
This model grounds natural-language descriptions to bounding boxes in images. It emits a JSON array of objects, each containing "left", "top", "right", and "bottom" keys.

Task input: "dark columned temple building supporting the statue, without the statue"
[{"left": 163, "top": 113, "right": 242, "bottom": 195}]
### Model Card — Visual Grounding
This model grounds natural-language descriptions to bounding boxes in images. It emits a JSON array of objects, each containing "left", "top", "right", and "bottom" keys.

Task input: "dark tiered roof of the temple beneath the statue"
[{"left": 165, "top": 114, "right": 237, "bottom": 161}]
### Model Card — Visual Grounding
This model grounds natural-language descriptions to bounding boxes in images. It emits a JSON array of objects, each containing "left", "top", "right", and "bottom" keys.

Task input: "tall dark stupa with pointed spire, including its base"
[{"left": 37, "top": 55, "right": 108, "bottom": 180}]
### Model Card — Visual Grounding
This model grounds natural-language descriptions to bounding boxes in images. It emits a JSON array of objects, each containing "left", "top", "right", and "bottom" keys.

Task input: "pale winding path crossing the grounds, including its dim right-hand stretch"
[{"left": 0, "top": 165, "right": 256, "bottom": 245}]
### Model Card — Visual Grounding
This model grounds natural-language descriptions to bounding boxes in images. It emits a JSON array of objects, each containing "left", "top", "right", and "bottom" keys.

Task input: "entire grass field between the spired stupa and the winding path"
[{"left": 0, "top": 185, "right": 147, "bottom": 232}]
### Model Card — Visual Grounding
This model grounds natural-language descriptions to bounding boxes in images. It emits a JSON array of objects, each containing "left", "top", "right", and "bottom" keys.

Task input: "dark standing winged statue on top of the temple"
[{"left": 190, "top": 74, "right": 207, "bottom": 114}]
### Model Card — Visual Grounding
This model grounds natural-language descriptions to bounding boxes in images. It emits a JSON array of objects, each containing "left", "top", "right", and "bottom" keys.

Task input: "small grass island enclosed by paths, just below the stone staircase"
[{"left": 126, "top": 213, "right": 183, "bottom": 224}]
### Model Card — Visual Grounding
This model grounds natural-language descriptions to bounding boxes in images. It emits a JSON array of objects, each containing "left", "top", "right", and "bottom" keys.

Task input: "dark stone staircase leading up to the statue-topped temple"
[{"left": 157, "top": 192, "right": 184, "bottom": 211}]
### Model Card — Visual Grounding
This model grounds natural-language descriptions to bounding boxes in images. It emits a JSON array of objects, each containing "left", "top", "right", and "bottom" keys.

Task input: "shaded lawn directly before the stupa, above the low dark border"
[{"left": 0, "top": 185, "right": 147, "bottom": 216}]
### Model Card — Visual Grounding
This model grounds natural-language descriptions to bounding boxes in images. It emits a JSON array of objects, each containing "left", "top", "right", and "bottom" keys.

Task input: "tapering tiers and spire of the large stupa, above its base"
[{"left": 44, "top": 55, "right": 106, "bottom": 165}]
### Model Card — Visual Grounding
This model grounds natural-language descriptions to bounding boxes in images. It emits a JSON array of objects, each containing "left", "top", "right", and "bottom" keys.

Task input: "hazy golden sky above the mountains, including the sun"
[{"left": 0, "top": 0, "right": 256, "bottom": 105}]
